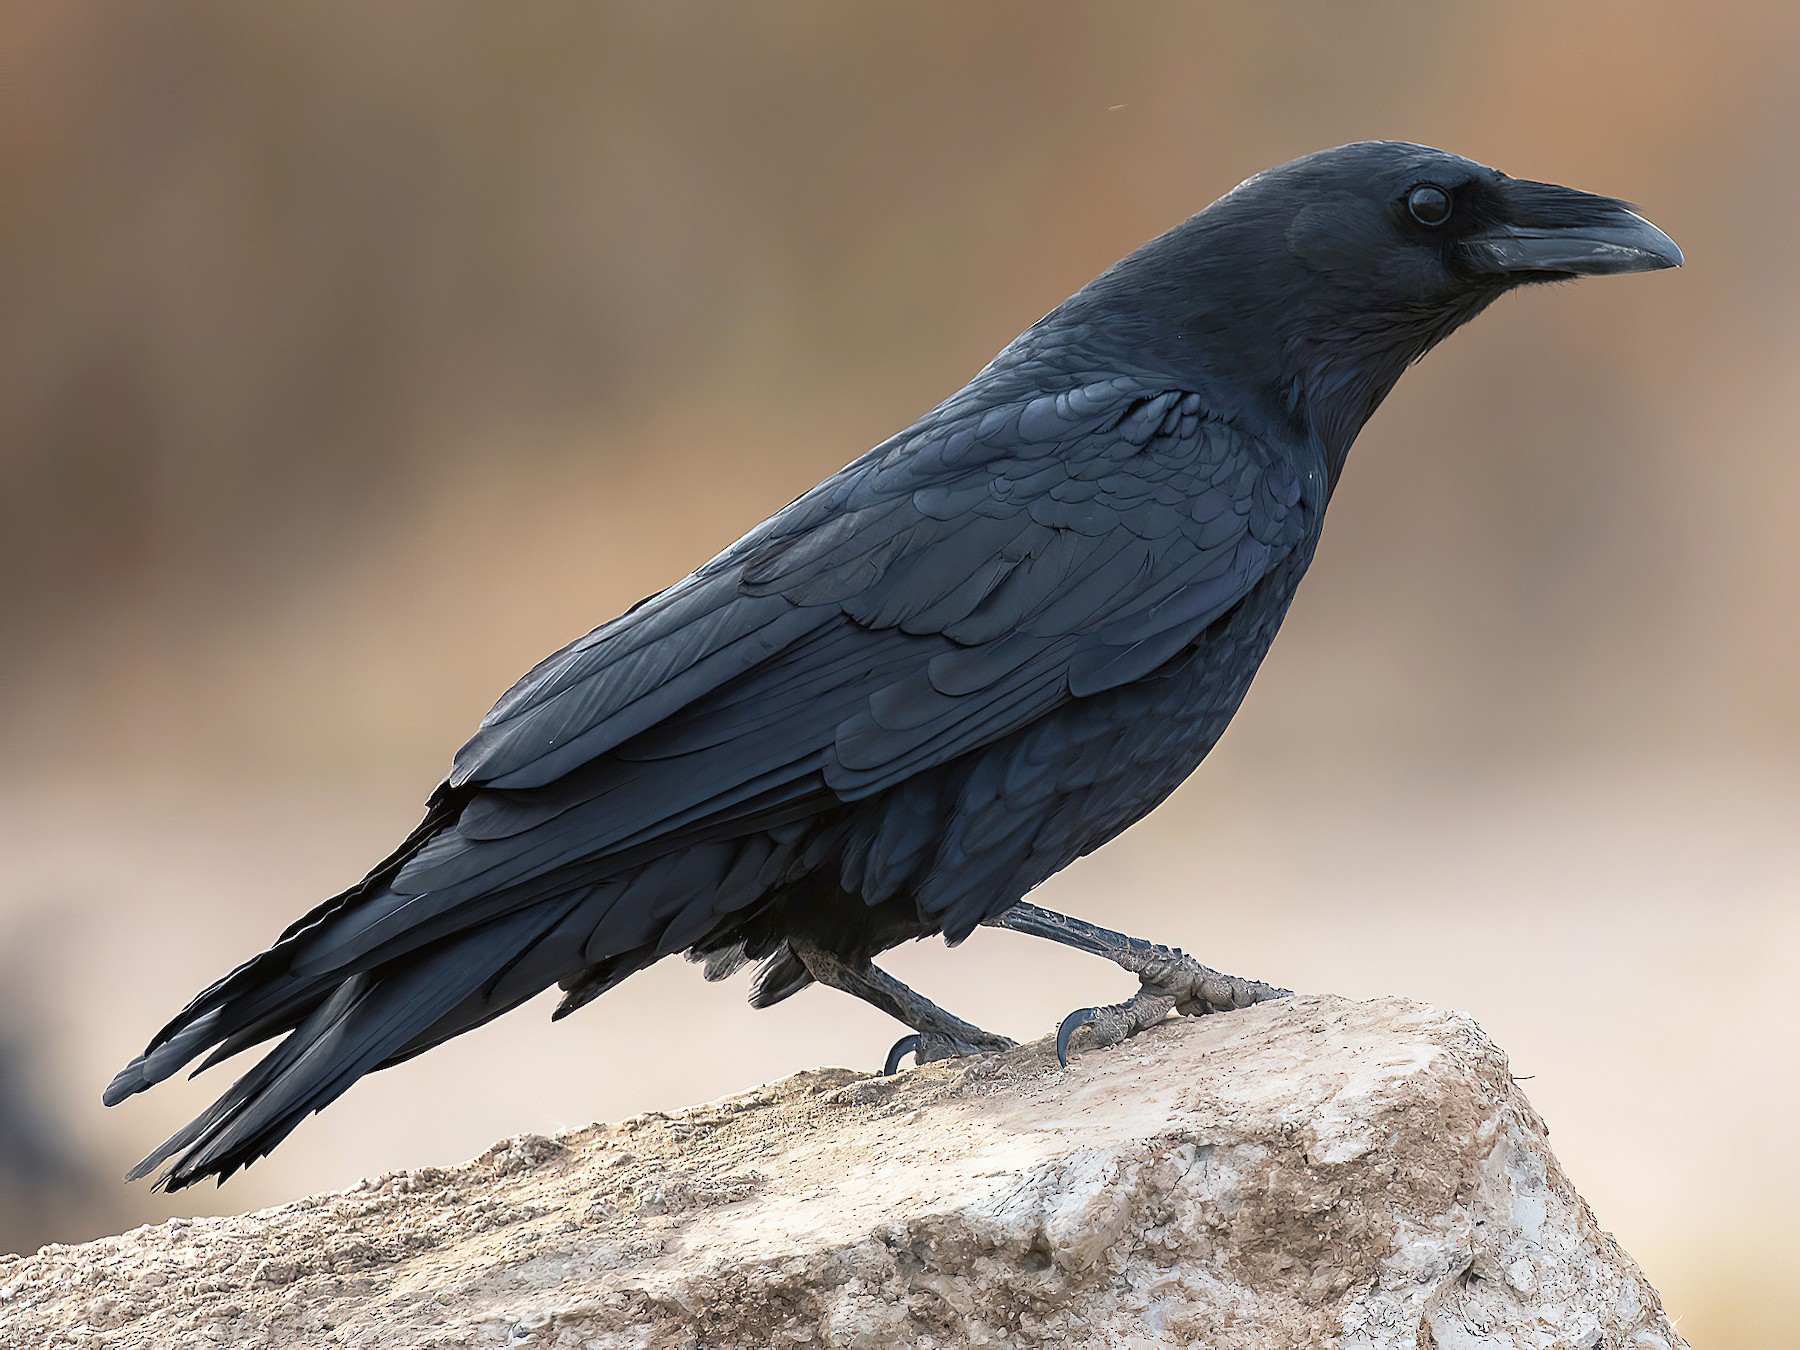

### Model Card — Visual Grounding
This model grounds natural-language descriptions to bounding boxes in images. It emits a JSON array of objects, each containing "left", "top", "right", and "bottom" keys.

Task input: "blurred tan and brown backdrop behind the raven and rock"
[{"left": 0, "top": 0, "right": 1800, "bottom": 1346}]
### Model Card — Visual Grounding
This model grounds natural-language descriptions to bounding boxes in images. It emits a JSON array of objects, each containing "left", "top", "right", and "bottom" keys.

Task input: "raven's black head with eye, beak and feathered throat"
[{"left": 1089, "top": 140, "right": 1681, "bottom": 472}]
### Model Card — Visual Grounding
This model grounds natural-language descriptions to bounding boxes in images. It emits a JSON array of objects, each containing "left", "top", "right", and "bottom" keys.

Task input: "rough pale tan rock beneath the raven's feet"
[{"left": 0, "top": 997, "right": 1683, "bottom": 1350}]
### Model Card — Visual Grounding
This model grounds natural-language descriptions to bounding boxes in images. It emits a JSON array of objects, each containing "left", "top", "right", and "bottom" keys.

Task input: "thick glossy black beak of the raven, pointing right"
[{"left": 1462, "top": 180, "right": 1681, "bottom": 281}]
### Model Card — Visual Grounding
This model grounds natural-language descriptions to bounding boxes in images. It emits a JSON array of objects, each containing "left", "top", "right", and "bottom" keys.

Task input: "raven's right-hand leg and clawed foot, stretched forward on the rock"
[{"left": 988, "top": 902, "right": 1291, "bottom": 1064}]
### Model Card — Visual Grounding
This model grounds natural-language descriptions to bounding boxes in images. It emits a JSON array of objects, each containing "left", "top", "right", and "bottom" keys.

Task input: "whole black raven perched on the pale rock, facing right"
[{"left": 106, "top": 142, "right": 1681, "bottom": 1190}]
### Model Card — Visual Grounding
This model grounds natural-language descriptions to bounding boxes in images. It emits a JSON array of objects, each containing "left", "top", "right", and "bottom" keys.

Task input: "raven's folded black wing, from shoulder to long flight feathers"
[{"left": 270, "top": 380, "right": 1318, "bottom": 972}]
